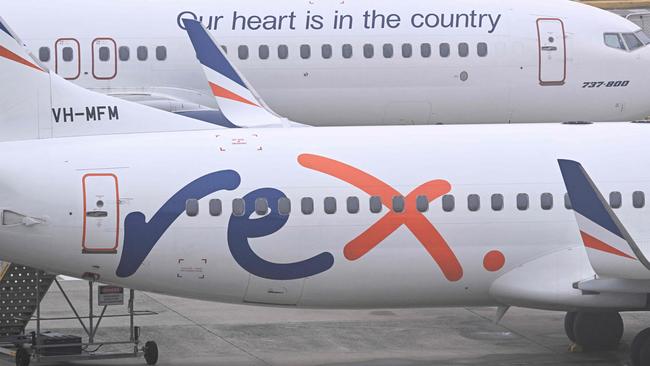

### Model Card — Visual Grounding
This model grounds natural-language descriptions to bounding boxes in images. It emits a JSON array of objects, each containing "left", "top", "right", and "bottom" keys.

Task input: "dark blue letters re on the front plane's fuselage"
[{"left": 116, "top": 170, "right": 334, "bottom": 280}]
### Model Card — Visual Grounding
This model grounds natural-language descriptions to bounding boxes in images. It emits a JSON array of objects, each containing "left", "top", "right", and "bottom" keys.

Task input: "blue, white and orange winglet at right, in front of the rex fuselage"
[{"left": 558, "top": 160, "right": 650, "bottom": 279}]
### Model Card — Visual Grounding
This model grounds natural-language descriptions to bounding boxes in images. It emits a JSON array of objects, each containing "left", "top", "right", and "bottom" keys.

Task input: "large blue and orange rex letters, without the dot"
[{"left": 116, "top": 154, "right": 463, "bottom": 282}]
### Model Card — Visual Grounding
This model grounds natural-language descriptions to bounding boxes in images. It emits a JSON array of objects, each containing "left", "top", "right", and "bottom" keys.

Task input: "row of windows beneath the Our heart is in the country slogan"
[{"left": 232, "top": 42, "right": 488, "bottom": 60}]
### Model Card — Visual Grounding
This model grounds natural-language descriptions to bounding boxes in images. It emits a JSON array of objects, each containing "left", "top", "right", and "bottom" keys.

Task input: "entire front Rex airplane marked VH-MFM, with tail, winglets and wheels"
[{"left": 0, "top": 10, "right": 650, "bottom": 366}]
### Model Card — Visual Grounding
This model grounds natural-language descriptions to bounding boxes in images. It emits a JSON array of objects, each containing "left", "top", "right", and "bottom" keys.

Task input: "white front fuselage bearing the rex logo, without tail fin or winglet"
[{"left": 0, "top": 123, "right": 650, "bottom": 309}]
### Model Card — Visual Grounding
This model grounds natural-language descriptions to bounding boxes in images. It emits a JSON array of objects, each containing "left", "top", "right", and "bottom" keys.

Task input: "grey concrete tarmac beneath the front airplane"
[{"left": 0, "top": 281, "right": 650, "bottom": 366}]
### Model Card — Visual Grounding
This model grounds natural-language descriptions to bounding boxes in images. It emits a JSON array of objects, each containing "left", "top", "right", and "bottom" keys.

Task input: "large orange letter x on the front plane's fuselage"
[{"left": 298, "top": 154, "right": 463, "bottom": 281}]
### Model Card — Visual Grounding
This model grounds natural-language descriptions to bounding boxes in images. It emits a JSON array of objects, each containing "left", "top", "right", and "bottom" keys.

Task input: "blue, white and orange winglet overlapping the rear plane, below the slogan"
[{"left": 183, "top": 19, "right": 289, "bottom": 127}]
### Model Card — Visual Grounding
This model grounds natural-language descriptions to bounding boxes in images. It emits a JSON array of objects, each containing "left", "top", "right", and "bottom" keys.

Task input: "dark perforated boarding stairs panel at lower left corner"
[{"left": 0, "top": 262, "right": 56, "bottom": 337}]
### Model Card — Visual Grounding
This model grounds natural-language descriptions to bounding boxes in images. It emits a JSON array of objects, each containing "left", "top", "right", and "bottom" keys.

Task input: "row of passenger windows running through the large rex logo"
[{"left": 185, "top": 191, "right": 646, "bottom": 217}]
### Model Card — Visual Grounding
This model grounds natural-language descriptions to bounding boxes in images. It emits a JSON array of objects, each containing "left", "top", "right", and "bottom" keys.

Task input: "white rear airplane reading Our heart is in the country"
[{"left": 3, "top": 0, "right": 650, "bottom": 125}]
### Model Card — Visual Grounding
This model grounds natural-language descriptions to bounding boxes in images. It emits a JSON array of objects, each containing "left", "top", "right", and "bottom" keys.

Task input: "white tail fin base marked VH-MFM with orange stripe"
[{"left": 0, "top": 18, "right": 221, "bottom": 142}]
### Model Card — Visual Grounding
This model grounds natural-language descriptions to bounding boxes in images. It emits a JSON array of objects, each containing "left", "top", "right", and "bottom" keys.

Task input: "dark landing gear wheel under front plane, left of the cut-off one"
[{"left": 573, "top": 312, "right": 623, "bottom": 351}]
